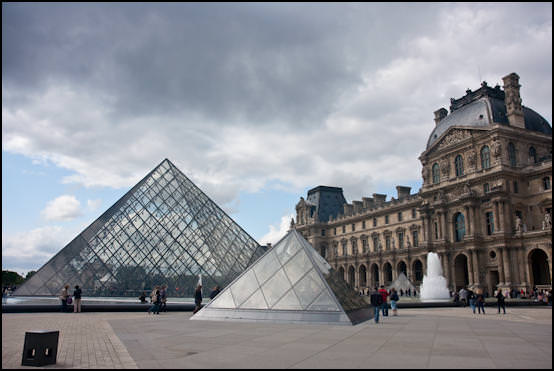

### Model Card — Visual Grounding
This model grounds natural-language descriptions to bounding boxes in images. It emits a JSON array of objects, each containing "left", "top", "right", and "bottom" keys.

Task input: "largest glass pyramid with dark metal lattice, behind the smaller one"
[{"left": 14, "top": 159, "right": 265, "bottom": 297}]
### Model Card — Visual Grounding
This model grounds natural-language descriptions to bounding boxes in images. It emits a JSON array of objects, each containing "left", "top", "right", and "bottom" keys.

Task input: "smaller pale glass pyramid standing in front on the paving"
[{"left": 191, "top": 229, "right": 373, "bottom": 325}]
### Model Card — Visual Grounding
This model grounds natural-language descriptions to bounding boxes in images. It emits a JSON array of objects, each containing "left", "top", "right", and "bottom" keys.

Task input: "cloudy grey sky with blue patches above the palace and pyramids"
[{"left": 2, "top": 3, "right": 552, "bottom": 272}]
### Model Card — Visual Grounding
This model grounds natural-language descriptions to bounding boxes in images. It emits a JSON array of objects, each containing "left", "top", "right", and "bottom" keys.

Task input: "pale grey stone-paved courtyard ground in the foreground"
[{"left": 2, "top": 307, "right": 552, "bottom": 369}]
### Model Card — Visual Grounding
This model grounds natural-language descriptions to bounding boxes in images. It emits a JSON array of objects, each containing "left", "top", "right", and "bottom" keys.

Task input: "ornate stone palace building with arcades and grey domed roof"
[{"left": 295, "top": 73, "right": 552, "bottom": 294}]
